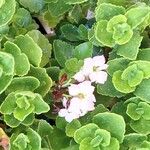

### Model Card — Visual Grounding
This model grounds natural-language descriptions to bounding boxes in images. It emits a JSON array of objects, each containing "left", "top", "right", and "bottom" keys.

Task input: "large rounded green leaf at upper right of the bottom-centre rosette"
[{"left": 93, "top": 112, "right": 125, "bottom": 143}]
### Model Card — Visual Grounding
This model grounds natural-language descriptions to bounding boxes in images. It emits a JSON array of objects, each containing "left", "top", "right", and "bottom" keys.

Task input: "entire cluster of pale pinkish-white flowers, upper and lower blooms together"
[{"left": 59, "top": 56, "right": 108, "bottom": 122}]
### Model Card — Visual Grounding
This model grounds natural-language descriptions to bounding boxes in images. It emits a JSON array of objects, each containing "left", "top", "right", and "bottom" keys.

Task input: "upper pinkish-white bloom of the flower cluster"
[{"left": 73, "top": 55, "right": 108, "bottom": 84}]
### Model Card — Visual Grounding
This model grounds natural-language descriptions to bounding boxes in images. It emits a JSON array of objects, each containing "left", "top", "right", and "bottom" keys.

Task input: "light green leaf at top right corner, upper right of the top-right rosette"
[{"left": 125, "top": 5, "right": 150, "bottom": 29}]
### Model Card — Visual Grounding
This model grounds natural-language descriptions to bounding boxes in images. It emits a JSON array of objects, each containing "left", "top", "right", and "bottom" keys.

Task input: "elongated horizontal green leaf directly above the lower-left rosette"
[{"left": 5, "top": 76, "right": 40, "bottom": 94}]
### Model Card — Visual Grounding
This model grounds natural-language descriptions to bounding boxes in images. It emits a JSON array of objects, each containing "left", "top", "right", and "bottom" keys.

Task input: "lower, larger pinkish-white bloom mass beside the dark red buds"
[{"left": 58, "top": 81, "right": 96, "bottom": 122}]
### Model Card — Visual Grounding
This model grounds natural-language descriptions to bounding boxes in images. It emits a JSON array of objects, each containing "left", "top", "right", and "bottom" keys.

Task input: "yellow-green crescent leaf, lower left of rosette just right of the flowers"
[{"left": 112, "top": 71, "right": 135, "bottom": 93}]
